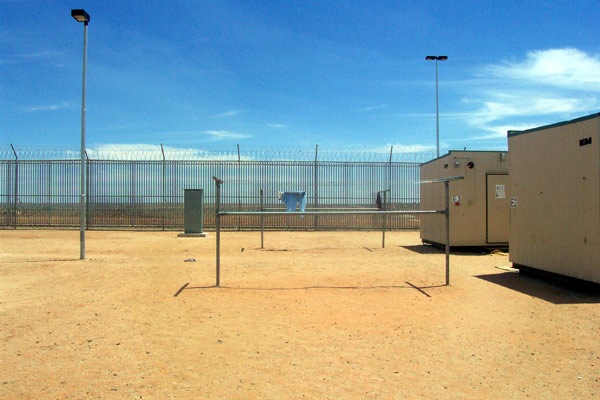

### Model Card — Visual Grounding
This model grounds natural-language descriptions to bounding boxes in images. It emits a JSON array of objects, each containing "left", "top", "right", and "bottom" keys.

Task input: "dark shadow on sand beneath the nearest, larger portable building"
[{"left": 475, "top": 272, "right": 600, "bottom": 304}]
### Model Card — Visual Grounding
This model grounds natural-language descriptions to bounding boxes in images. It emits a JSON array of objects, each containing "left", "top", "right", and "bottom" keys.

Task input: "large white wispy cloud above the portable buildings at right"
[{"left": 462, "top": 48, "right": 600, "bottom": 140}]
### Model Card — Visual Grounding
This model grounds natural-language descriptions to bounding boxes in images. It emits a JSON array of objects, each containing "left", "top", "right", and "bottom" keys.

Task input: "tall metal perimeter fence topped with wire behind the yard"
[{"left": 0, "top": 145, "right": 432, "bottom": 230}]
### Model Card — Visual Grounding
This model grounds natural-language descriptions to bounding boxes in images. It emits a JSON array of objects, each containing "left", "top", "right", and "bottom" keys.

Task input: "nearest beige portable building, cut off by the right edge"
[{"left": 508, "top": 114, "right": 600, "bottom": 283}]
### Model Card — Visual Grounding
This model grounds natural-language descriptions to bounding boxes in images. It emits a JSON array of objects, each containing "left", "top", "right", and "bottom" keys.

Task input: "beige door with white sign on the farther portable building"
[{"left": 486, "top": 175, "right": 510, "bottom": 244}]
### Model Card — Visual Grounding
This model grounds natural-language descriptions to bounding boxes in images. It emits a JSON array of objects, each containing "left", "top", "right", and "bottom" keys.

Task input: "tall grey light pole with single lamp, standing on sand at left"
[{"left": 71, "top": 10, "right": 90, "bottom": 260}]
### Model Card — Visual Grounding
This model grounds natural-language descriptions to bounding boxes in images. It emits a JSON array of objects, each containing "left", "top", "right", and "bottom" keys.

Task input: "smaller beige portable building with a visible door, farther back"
[{"left": 420, "top": 150, "right": 510, "bottom": 247}]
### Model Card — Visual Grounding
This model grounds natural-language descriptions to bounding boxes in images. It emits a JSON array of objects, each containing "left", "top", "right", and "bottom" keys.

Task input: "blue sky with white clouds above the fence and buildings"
[{"left": 0, "top": 0, "right": 600, "bottom": 158}]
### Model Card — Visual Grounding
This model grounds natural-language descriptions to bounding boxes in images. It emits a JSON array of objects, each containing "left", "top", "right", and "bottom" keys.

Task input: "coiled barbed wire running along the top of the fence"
[{"left": 0, "top": 144, "right": 445, "bottom": 163}]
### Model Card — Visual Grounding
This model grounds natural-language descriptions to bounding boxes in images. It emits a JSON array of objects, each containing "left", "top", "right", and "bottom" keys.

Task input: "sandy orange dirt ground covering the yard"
[{"left": 0, "top": 230, "right": 600, "bottom": 400}]
